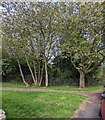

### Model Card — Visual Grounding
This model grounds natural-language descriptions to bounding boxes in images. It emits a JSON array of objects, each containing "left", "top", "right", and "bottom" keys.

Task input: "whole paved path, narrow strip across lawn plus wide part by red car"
[{"left": 0, "top": 88, "right": 102, "bottom": 120}]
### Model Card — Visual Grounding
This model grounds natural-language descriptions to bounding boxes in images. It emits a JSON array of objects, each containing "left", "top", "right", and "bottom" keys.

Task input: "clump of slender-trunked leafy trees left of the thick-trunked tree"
[{"left": 2, "top": 2, "right": 58, "bottom": 86}]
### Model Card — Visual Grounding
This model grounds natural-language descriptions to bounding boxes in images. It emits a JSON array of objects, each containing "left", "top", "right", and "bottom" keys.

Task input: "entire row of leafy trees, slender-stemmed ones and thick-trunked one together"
[{"left": 1, "top": 2, "right": 105, "bottom": 88}]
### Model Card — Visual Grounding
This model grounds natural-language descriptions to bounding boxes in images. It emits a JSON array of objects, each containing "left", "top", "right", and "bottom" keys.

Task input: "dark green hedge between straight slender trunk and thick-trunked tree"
[{"left": 49, "top": 56, "right": 79, "bottom": 85}]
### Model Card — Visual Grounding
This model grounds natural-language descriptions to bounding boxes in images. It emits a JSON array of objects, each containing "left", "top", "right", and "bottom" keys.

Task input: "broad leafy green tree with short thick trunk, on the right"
[{"left": 62, "top": 2, "right": 105, "bottom": 88}]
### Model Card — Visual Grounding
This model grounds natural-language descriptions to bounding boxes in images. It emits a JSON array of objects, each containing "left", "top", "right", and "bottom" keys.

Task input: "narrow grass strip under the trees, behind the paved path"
[{"left": 2, "top": 82, "right": 103, "bottom": 92}]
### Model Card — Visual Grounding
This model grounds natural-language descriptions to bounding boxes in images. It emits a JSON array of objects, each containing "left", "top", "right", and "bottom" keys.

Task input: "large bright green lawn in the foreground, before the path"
[{"left": 2, "top": 91, "right": 86, "bottom": 118}]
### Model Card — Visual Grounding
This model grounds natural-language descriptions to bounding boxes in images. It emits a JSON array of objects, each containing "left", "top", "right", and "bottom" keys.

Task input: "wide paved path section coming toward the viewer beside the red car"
[{"left": 74, "top": 93, "right": 101, "bottom": 120}]
